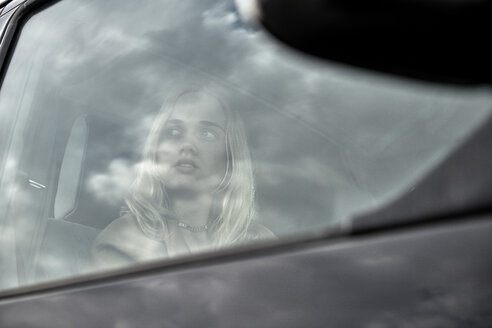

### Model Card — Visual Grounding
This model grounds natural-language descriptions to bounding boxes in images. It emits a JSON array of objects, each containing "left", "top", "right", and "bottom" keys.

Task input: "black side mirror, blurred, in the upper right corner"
[{"left": 252, "top": 0, "right": 492, "bottom": 84}]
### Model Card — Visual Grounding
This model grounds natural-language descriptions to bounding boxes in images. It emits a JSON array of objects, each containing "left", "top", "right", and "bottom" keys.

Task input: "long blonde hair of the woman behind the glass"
[{"left": 126, "top": 89, "right": 255, "bottom": 248}]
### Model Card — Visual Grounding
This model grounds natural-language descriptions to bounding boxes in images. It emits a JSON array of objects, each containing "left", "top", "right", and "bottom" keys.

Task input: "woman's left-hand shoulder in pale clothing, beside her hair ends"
[{"left": 92, "top": 214, "right": 167, "bottom": 267}]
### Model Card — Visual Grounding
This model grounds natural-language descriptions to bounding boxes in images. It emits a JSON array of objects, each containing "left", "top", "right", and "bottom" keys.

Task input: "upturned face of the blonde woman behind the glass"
[{"left": 157, "top": 93, "right": 227, "bottom": 193}]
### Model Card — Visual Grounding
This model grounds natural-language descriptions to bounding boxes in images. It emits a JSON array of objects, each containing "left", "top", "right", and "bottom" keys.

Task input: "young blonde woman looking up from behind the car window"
[{"left": 92, "top": 90, "right": 274, "bottom": 265}]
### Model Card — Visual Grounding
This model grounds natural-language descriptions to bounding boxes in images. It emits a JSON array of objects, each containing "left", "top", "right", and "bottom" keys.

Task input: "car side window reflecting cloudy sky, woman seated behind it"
[{"left": 0, "top": 0, "right": 492, "bottom": 288}]
